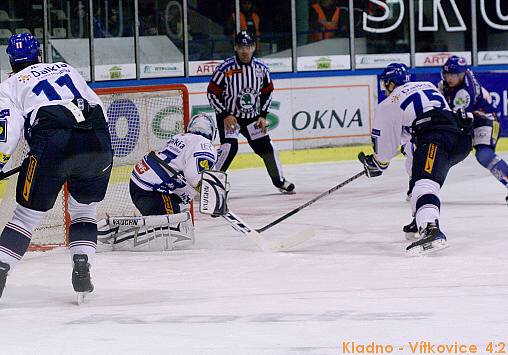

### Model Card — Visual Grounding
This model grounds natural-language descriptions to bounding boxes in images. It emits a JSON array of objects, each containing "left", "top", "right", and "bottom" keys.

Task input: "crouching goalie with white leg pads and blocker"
[{"left": 97, "top": 113, "right": 227, "bottom": 251}]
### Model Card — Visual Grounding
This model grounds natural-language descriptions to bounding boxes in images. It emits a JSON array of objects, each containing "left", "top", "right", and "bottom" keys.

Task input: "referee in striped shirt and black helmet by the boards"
[{"left": 208, "top": 31, "right": 295, "bottom": 193}]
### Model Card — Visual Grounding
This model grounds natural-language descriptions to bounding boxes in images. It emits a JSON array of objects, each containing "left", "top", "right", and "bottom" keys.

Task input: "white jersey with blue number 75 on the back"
[{"left": 371, "top": 81, "right": 451, "bottom": 164}]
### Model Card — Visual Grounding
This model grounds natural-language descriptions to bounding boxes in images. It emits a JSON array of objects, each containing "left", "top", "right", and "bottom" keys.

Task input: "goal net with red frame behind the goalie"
[{"left": 0, "top": 85, "right": 189, "bottom": 250}]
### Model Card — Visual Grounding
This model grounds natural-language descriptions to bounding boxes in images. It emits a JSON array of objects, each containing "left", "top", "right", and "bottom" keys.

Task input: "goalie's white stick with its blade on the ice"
[{"left": 149, "top": 152, "right": 314, "bottom": 252}]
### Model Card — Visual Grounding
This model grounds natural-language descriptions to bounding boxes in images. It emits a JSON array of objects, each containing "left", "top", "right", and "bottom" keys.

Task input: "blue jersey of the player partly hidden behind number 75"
[{"left": 438, "top": 69, "right": 496, "bottom": 114}]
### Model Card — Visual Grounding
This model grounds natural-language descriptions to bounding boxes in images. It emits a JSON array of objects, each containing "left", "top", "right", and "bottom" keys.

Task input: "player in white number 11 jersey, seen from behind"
[{"left": 0, "top": 33, "right": 113, "bottom": 299}]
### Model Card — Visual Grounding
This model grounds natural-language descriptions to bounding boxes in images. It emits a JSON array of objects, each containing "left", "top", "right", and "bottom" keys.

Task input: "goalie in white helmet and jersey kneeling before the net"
[{"left": 99, "top": 113, "right": 218, "bottom": 251}]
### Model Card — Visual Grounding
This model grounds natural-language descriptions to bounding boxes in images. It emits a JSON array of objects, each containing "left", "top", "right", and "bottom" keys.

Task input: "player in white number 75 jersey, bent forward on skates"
[{"left": 358, "top": 63, "right": 472, "bottom": 255}]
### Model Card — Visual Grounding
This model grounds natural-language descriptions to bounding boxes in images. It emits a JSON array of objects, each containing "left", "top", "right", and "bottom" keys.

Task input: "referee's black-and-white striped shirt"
[{"left": 208, "top": 56, "right": 273, "bottom": 119}]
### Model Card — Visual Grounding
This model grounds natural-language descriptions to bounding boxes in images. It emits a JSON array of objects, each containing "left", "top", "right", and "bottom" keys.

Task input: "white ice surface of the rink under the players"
[{"left": 0, "top": 154, "right": 508, "bottom": 355}]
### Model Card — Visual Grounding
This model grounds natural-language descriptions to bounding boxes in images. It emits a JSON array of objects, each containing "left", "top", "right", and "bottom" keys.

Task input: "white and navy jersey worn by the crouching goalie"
[{"left": 131, "top": 133, "right": 217, "bottom": 203}]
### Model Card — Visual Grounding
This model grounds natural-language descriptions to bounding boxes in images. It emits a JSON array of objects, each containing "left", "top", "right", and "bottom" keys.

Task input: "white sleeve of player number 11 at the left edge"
[{"left": 0, "top": 93, "right": 25, "bottom": 171}]
